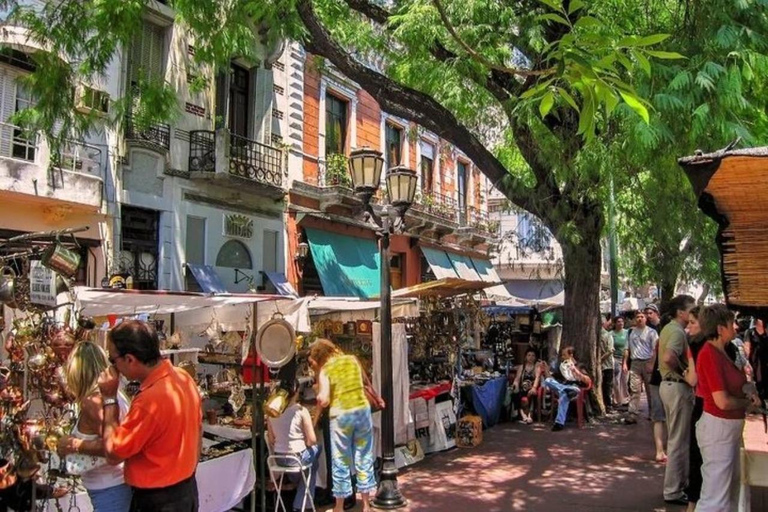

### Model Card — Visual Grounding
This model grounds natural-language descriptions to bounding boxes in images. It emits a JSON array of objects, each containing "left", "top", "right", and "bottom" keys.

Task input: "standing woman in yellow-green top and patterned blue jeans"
[{"left": 309, "top": 339, "right": 376, "bottom": 512}]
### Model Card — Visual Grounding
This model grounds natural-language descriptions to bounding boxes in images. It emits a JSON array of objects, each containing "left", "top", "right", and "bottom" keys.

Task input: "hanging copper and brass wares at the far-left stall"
[{"left": 0, "top": 227, "right": 96, "bottom": 510}]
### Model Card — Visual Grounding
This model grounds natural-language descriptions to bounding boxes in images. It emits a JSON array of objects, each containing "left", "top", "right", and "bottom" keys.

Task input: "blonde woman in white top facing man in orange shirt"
[{"left": 58, "top": 341, "right": 131, "bottom": 512}]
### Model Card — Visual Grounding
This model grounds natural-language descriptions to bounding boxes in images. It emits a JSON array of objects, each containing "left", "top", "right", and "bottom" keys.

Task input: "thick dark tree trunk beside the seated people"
[{"left": 560, "top": 222, "right": 605, "bottom": 411}]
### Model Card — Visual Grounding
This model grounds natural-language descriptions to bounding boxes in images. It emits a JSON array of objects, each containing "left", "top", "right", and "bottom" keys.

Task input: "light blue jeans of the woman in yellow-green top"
[{"left": 331, "top": 407, "right": 376, "bottom": 498}]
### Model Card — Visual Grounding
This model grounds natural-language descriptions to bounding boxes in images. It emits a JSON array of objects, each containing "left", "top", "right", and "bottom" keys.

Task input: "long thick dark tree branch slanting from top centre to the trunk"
[{"left": 296, "top": 0, "right": 538, "bottom": 211}]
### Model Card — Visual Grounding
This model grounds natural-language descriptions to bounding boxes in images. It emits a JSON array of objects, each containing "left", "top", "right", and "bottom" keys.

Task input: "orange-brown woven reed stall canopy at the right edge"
[{"left": 678, "top": 147, "right": 768, "bottom": 314}]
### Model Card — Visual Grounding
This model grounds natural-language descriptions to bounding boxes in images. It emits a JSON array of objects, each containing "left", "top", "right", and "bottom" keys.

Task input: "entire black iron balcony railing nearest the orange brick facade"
[{"left": 189, "top": 130, "right": 283, "bottom": 188}]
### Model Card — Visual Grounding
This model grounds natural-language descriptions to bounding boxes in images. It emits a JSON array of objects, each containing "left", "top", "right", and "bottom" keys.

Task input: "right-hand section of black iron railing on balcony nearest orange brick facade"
[{"left": 229, "top": 134, "right": 283, "bottom": 187}]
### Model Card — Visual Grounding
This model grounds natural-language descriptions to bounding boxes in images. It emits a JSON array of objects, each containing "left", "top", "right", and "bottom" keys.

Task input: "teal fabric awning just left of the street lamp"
[{"left": 304, "top": 228, "right": 381, "bottom": 299}]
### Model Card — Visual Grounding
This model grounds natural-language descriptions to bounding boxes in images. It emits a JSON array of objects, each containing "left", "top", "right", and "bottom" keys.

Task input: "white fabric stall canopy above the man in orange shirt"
[{"left": 75, "top": 286, "right": 290, "bottom": 316}]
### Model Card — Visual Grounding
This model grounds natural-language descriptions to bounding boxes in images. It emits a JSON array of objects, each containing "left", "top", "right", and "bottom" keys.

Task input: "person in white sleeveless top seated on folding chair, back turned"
[{"left": 267, "top": 380, "right": 320, "bottom": 511}]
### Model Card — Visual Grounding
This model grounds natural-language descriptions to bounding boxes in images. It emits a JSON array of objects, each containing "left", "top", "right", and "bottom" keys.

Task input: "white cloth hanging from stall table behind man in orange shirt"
[{"left": 48, "top": 448, "right": 256, "bottom": 512}]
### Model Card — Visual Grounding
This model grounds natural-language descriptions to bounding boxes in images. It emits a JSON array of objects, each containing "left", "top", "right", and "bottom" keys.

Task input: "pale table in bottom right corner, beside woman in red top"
[{"left": 739, "top": 416, "right": 768, "bottom": 512}]
